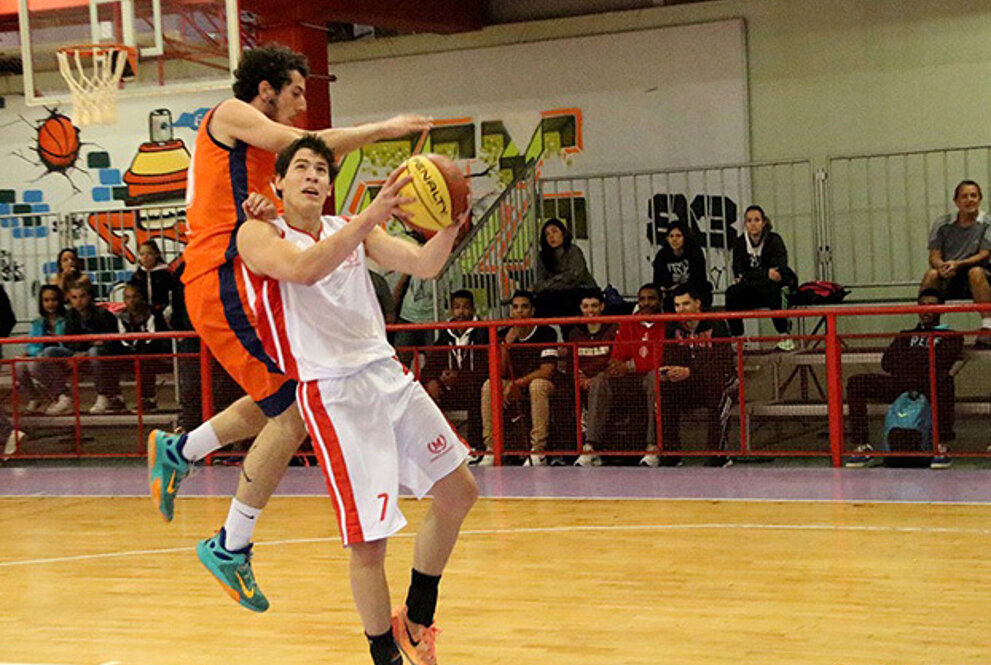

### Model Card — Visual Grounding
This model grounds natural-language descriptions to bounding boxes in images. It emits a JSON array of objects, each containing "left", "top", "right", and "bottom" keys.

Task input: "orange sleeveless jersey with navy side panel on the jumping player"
[{"left": 182, "top": 107, "right": 281, "bottom": 284}]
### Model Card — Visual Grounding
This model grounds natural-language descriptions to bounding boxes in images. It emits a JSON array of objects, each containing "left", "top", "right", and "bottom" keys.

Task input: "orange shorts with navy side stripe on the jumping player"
[{"left": 185, "top": 258, "right": 296, "bottom": 418}]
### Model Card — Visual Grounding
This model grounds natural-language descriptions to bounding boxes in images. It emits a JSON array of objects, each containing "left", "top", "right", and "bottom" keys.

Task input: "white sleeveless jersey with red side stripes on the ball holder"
[{"left": 242, "top": 216, "right": 396, "bottom": 381}]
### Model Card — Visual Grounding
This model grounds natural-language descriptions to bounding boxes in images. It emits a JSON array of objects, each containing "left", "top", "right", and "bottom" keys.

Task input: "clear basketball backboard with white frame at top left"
[{"left": 17, "top": 0, "right": 240, "bottom": 106}]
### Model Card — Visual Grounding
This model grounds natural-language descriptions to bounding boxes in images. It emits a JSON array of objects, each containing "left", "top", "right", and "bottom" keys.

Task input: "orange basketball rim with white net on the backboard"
[{"left": 58, "top": 44, "right": 138, "bottom": 127}]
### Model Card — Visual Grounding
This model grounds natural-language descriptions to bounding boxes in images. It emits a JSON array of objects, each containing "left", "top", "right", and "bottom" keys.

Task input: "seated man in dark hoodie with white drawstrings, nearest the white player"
[{"left": 420, "top": 289, "right": 489, "bottom": 449}]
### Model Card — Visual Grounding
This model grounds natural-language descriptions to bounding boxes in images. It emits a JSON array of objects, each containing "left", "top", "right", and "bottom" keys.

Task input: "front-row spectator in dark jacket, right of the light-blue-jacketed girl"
[{"left": 65, "top": 283, "right": 126, "bottom": 414}]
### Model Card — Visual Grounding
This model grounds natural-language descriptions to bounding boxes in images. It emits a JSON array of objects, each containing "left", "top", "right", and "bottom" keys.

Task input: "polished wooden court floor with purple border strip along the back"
[{"left": 0, "top": 466, "right": 991, "bottom": 665}]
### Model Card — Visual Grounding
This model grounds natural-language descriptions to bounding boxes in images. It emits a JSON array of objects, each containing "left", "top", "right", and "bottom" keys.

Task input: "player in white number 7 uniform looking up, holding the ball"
[{"left": 237, "top": 136, "right": 478, "bottom": 665}]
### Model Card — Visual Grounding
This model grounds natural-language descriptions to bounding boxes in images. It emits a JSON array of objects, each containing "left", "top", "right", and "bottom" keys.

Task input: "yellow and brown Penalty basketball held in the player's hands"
[{"left": 399, "top": 153, "right": 468, "bottom": 233}]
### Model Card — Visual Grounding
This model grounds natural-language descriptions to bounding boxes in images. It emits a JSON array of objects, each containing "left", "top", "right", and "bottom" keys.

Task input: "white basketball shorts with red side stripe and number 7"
[{"left": 297, "top": 359, "right": 469, "bottom": 546}]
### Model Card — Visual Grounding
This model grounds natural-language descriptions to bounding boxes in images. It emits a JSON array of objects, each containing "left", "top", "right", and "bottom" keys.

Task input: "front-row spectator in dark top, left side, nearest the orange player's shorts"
[{"left": 115, "top": 284, "right": 172, "bottom": 411}]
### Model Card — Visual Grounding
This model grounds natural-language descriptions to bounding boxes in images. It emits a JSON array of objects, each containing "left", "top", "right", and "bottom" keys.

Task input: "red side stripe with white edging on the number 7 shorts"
[{"left": 299, "top": 381, "right": 365, "bottom": 545}]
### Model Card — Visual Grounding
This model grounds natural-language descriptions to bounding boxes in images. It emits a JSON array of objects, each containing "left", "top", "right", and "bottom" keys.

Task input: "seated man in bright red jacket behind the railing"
[{"left": 585, "top": 284, "right": 668, "bottom": 466}]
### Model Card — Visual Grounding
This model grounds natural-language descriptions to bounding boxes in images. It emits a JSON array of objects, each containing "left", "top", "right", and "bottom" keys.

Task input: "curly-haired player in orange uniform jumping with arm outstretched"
[{"left": 148, "top": 45, "right": 430, "bottom": 612}]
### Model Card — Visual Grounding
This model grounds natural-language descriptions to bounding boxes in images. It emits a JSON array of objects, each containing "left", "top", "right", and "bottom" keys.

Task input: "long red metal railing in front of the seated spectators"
[{"left": 0, "top": 304, "right": 991, "bottom": 466}]
